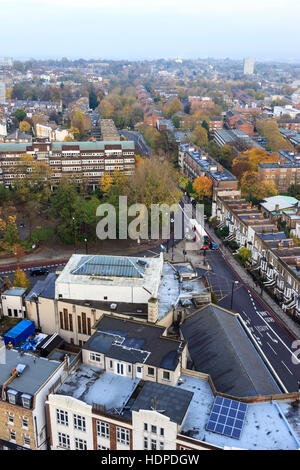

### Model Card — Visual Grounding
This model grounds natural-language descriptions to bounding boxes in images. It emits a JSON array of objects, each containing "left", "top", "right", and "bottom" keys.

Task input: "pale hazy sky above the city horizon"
[{"left": 0, "top": 0, "right": 300, "bottom": 61}]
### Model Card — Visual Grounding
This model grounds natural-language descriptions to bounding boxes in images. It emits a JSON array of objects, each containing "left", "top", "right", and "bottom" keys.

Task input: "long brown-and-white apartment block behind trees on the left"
[{"left": 0, "top": 141, "right": 135, "bottom": 188}]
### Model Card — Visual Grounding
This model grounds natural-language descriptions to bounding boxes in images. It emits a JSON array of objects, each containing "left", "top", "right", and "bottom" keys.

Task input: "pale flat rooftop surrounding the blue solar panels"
[{"left": 176, "top": 375, "right": 300, "bottom": 450}]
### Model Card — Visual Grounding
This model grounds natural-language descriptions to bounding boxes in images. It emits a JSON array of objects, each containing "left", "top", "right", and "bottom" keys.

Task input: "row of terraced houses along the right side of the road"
[{"left": 216, "top": 195, "right": 300, "bottom": 317}]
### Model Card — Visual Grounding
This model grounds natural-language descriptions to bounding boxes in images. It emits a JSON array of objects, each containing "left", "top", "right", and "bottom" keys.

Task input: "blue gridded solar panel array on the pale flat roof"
[{"left": 206, "top": 395, "right": 247, "bottom": 439}]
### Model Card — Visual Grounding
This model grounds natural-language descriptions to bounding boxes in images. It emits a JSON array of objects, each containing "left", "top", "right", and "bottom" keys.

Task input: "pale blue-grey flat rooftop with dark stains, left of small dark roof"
[{"left": 56, "top": 364, "right": 140, "bottom": 412}]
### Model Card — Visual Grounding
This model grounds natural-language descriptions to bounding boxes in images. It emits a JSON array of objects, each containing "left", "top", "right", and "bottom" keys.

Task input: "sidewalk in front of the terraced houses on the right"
[{"left": 205, "top": 224, "right": 300, "bottom": 339}]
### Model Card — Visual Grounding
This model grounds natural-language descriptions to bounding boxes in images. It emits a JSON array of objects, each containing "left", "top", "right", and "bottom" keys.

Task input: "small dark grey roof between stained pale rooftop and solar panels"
[{"left": 131, "top": 381, "right": 194, "bottom": 424}]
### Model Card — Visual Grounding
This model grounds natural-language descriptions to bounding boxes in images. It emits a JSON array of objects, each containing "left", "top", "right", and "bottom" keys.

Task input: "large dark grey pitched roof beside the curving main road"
[{"left": 181, "top": 304, "right": 281, "bottom": 397}]
